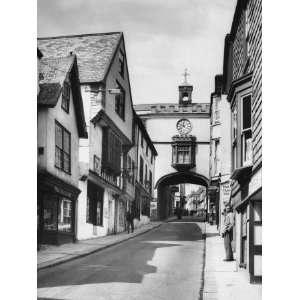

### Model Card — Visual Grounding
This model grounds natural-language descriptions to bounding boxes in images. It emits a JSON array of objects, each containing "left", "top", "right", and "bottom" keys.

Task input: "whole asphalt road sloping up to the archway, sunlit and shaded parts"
[{"left": 38, "top": 220, "right": 204, "bottom": 300}]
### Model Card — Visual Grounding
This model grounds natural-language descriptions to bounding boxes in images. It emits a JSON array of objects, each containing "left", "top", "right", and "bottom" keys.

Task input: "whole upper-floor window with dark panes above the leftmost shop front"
[{"left": 55, "top": 121, "right": 71, "bottom": 174}]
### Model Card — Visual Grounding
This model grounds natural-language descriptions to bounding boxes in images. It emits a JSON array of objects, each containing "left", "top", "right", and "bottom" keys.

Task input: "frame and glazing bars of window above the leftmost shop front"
[{"left": 54, "top": 120, "right": 72, "bottom": 175}]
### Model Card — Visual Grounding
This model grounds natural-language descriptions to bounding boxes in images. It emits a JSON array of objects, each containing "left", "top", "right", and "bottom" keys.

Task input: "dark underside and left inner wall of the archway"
[{"left": 155, "top": 171, "right": 209, "bottom": 220}]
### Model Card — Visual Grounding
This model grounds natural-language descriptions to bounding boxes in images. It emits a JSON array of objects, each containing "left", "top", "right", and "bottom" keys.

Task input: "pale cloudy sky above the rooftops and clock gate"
[{"left": 37, "top": 0, "right": 236, "bottom": 104}]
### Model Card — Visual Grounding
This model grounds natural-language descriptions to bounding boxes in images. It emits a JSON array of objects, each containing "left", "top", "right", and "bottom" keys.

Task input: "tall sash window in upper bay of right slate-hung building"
[{"left": 241, "top": 95, "right": 252, "bottom": 166}]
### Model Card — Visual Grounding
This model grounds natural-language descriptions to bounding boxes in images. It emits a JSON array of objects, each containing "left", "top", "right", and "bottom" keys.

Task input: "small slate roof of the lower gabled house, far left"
[{"left": 38, "top": 55, "right": 75, "bottom": 107}]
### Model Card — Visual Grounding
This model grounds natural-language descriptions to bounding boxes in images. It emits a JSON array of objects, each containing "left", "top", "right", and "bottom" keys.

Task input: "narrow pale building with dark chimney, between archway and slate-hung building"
[{"left": 209, "top": 75, "right": 231, "bottom": 231}]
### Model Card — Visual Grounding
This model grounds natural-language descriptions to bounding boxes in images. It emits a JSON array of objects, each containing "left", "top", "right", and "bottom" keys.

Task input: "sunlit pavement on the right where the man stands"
[{"left": 203, "top": 223, "right": 262, "bottom": 300}]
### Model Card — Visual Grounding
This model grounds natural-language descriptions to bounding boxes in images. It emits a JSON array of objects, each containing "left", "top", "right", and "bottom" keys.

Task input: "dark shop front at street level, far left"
[{"left": 37, "top": 173, "right": 80, "bottom": 245}]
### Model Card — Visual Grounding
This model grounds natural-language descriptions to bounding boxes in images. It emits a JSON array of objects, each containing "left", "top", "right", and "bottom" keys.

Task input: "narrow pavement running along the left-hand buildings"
[{"left": 37, "top": 222, "right": 162, "bottom": 270}]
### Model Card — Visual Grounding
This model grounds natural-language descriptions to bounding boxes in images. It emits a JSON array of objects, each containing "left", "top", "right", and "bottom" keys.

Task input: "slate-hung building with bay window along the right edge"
[{"left": 223, "top": 0, "right": 262, "bottom": 282}]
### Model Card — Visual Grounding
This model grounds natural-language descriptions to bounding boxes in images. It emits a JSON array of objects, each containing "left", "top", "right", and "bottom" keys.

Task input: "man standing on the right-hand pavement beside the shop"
[{"left": 222, "top": 203, "right": 234, "bottom": 261}]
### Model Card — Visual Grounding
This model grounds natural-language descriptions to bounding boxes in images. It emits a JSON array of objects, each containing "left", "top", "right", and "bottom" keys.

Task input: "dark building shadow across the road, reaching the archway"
[{"left": 37, "top": 223, "right": 203, "bottom": 290}]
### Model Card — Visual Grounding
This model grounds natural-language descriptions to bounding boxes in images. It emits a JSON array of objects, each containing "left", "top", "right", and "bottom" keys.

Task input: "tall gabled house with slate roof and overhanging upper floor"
[{"left": 38, "top": 32, "right": 135, "bottom": 240}]
